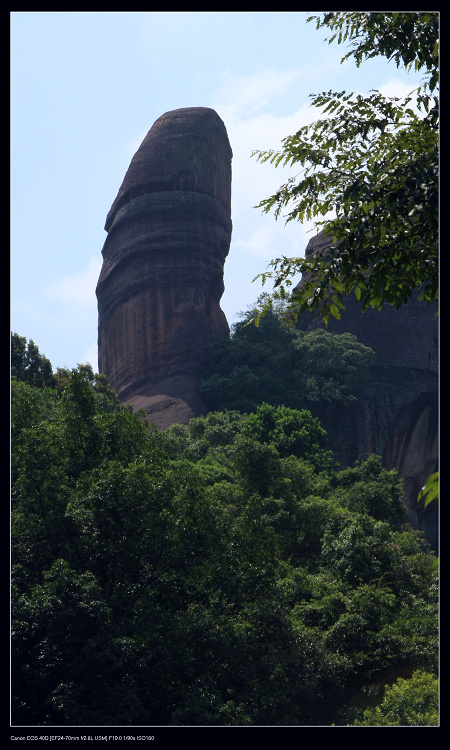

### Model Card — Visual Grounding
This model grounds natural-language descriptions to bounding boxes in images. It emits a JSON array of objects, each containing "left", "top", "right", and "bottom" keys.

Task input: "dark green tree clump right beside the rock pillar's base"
[{"left": 202, "top": 296, "right": 375, "bottom": 418}]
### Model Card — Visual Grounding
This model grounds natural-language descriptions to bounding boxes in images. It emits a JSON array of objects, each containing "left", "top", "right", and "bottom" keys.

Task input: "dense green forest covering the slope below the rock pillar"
[{"left": 11, "top": 330, "right": 438, "bottom": 726}]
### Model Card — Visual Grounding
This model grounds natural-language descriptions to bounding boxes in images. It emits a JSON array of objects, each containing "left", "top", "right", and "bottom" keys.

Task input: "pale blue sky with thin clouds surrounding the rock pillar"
[{"left": 10, "top": 12, "right": 426, "bottom": 370}]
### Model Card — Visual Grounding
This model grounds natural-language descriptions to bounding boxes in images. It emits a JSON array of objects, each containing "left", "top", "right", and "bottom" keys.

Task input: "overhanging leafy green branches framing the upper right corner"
[{"left": 252, "top": 12, "right": 439, "bottom": 321}]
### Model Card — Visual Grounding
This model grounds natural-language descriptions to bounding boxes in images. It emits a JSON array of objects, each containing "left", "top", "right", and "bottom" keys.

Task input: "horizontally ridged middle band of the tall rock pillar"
[{"left": 97, "top": 191, "right": 231, "bottom": 317}]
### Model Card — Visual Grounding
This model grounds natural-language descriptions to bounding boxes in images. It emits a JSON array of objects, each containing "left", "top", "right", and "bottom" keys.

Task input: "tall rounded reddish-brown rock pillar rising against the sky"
[{"left": 96, "top": 107, "right": 232, "bottom": 429}]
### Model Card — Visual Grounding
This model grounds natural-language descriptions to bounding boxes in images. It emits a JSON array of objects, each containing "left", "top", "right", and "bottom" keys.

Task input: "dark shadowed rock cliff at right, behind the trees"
[{"left": 299, "top": 232, "right": 438, "bottom": 547}]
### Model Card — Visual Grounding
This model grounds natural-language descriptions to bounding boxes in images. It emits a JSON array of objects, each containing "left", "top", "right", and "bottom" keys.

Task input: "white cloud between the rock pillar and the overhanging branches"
[{"left": 212, "top": 69, "right": 317, "bottom": 320}]
